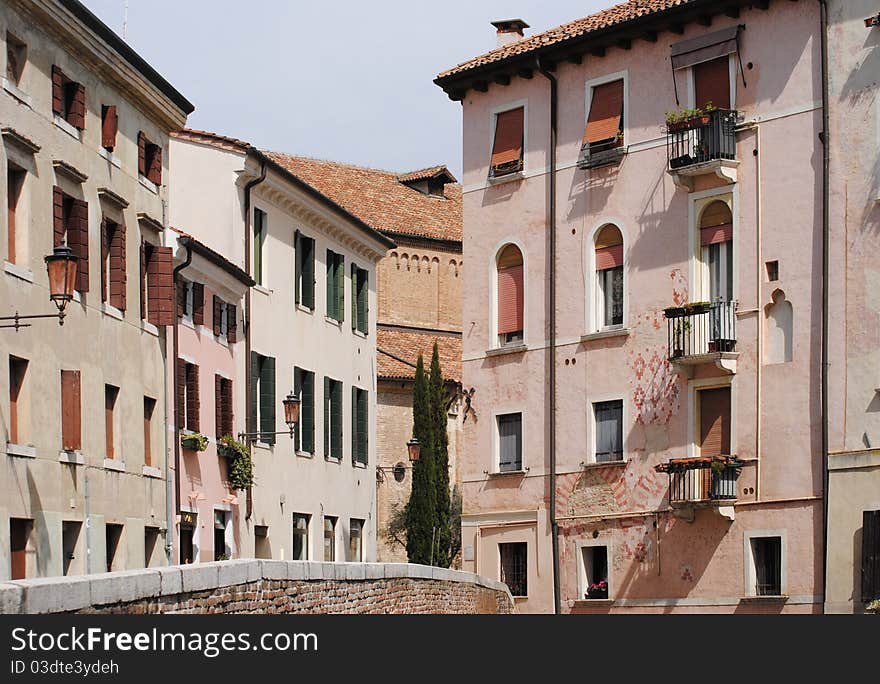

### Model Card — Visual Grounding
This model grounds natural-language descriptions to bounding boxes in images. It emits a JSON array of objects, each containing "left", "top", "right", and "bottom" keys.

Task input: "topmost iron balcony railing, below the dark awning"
[{"left": 666, "top": 109, "right": 737, "bottom": 171}]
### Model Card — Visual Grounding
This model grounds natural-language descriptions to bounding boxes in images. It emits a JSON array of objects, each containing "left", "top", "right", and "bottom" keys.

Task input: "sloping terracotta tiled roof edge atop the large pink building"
[{"left": 438, "top": 0, "right": 696, "bottom": 79}]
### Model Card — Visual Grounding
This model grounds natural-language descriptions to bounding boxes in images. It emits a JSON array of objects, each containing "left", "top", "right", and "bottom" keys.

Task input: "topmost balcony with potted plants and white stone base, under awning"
[{"left": 666, "top": 109, "right": 739, "bottom": 191}]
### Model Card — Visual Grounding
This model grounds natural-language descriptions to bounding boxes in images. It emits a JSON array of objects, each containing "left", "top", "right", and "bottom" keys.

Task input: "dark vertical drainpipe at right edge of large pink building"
[{"left": 819, "top": 0, "right": 831, "bottom": 610}]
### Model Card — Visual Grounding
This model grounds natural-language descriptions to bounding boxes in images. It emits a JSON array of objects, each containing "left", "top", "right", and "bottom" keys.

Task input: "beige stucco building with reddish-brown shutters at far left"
[{"left": 0, "top": 0, "right": 193, "bottom": 578}]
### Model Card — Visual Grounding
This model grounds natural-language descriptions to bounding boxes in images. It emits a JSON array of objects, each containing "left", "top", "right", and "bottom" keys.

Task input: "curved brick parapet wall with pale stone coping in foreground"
[{"left": 0, "top": 560, "right": 514, "bottom": 614}]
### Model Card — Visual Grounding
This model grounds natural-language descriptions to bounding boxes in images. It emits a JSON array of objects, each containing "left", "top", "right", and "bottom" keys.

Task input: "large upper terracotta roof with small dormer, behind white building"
[{"left": 263, "top": 151, "right": 462, "bottom": 241}]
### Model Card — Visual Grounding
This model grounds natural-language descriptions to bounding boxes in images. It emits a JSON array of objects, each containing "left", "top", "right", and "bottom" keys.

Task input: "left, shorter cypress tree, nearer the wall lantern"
[{"left": 406, "top": 355, "right": 437, "bottom": 565}]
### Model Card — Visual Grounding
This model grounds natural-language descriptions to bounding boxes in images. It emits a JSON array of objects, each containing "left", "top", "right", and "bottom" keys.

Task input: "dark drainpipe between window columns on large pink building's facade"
[{"left": 536, "top": 57, "right": 561, "bottom": 615}]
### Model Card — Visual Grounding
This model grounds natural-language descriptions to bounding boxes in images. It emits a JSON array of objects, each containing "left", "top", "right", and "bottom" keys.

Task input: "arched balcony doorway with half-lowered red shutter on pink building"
[{"left": 700, "top": 200, "right": 733, "bottom": 302}]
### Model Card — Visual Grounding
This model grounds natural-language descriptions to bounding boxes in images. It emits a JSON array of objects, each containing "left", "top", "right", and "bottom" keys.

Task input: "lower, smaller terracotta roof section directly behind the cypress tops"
[{"left": 376, "top": 328, "right": 461, "bottom": 382}]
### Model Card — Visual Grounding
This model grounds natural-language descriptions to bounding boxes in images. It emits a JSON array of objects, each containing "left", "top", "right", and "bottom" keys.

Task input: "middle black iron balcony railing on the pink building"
[{"left": 663, "top": 300, "right": 736, "bottom": 360}]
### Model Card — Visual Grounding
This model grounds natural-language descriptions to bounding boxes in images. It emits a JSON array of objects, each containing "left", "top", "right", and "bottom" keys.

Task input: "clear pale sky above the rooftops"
[{"left": 84, "top": 0, "right": 615, "bottom": 177}]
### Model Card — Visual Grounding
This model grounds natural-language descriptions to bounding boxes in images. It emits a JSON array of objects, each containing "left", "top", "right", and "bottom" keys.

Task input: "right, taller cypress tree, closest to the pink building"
[{"left": 428, "top": 342, "right": 452, "bottom": 568}]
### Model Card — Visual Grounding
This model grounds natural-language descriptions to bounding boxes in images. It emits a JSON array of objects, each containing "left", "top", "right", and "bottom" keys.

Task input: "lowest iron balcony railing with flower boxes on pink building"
[{"left": 655, "top": 456, "right": 745, "bottom": 505}]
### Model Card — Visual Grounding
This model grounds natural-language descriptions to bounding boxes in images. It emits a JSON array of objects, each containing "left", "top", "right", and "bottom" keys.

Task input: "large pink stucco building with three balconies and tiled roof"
[{"left": 436, "top": 0, "right": 825, "bottom": 612}]
